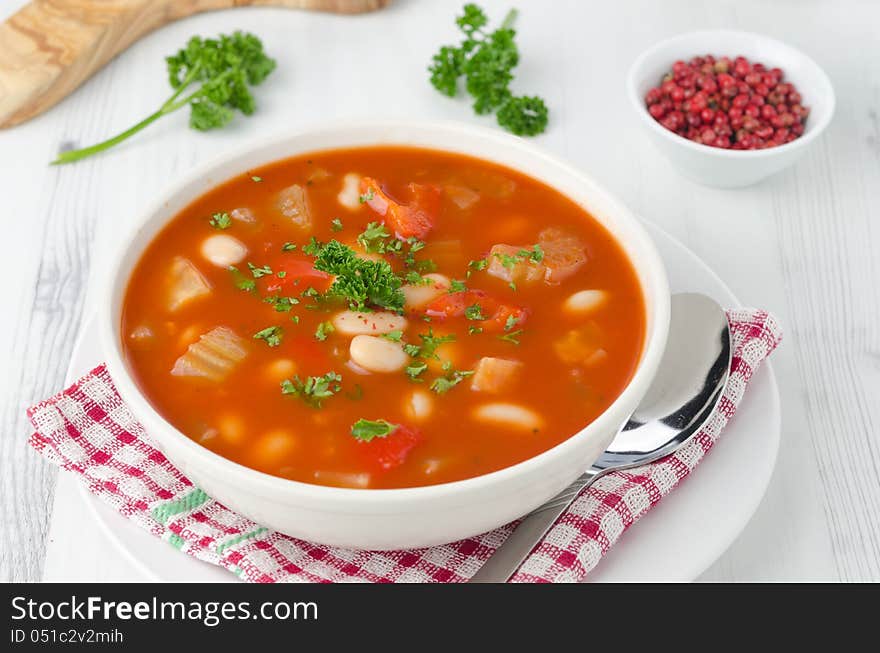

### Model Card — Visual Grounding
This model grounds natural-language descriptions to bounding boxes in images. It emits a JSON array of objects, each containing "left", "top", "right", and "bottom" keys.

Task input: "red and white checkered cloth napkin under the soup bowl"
[{"left": 28, "top": 309, "right": 781, "bottom": 583}]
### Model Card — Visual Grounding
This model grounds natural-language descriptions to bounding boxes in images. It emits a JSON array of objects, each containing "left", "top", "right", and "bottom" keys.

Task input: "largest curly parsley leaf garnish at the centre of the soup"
[{"left": 315, "top": 240, "right": 404, "bottom": 311}]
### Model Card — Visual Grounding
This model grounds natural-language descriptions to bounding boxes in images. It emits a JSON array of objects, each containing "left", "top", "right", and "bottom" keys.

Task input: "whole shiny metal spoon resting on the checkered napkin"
[{"left": 470, "top": 293, "right": 731, "bottom": 583}]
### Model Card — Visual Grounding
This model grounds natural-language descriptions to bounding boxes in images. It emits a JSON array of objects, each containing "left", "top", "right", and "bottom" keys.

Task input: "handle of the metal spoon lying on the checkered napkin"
[{"left": 470, "top": 467, "right": 611, "bottom": 583}]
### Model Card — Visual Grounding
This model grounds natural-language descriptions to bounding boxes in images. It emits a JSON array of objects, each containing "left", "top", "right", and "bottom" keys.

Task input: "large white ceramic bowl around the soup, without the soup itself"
[{"left": 98, "top": 121, "right": 670, "bottom": 549}]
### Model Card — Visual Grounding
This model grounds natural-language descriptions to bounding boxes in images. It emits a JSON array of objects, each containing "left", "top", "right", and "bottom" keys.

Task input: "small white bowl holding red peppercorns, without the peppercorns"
[{"left": 627, "top": 30, "right": 835, "bottom": 188}]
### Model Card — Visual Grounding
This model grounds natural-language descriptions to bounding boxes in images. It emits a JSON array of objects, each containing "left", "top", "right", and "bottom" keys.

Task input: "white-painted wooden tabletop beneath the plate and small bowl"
[{"left": 0, "top": 0, "right": 880, "bottom": 581}]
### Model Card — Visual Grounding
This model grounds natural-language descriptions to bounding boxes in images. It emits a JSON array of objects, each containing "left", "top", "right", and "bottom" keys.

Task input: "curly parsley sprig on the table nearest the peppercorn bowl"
[{"left": 428, "top": 3, "right": 548, "bottom": 136}]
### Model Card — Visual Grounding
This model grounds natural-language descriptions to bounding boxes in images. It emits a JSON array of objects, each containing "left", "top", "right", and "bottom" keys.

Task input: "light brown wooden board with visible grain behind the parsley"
[{"left": 0, "top": 0, "right": 391, "bottom": 128}]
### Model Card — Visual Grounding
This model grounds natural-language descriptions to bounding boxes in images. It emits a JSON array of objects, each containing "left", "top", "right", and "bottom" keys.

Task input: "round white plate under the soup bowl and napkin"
[{"left": 56, "top": 223, "right": 780, "bottom": 582}]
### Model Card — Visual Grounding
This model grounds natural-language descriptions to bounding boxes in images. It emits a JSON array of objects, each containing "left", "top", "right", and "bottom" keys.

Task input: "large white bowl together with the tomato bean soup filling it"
[{"left": 100, "top": 122, "right": 669, "bottom": 549}]
